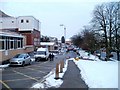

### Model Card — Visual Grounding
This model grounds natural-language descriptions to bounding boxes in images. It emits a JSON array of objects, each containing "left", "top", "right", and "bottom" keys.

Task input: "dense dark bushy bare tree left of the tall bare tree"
[{"left": 71, "top": 26, "right": 97, "bottom": 53}]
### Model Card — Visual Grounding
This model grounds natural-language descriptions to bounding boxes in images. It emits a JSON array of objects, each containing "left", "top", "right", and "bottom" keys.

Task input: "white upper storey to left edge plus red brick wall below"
[{"left": 0, "top": 16, "right": 41, "bottom": 46}]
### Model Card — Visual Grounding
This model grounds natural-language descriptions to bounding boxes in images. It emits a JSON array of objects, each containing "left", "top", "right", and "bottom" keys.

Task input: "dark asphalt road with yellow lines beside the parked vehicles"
[{"left": 0, "top": 52, "right": 76, "bottom": 90}]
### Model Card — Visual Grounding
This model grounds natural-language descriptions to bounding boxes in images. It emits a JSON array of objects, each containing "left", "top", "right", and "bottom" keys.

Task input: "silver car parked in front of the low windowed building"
[{"left": 10, "top": 53, "right": 32, "bottom": 66}]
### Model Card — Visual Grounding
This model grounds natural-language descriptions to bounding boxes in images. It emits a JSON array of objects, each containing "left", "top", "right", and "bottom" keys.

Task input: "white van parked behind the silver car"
[{"left": 34, "top": 48, "right": 49, "bottom": 61}]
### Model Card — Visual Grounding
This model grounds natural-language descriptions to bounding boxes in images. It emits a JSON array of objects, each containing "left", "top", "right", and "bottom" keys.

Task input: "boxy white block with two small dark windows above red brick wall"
[{"left": 17, "top": 16, "right": 40, "bottom": 47}]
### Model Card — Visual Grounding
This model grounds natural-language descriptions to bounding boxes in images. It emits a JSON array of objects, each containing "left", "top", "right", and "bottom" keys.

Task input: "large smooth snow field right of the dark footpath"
[{"left": 74, "top": 60, "right": 118, "bottom": 88}]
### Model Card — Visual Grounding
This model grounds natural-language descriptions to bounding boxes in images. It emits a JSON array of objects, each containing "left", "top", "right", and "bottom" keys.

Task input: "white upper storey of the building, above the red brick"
[{"left": 0, "top": 16, "right": 41, "bottom": 31}]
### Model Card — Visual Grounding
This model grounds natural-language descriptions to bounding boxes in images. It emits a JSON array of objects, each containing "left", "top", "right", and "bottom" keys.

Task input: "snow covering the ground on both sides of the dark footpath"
[{"left": 32, "top": 51, "right": 119, "bottom": 88}]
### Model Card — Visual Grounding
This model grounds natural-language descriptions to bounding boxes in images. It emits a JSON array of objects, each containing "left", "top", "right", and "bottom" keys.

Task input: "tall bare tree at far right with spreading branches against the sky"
[{"left": 92, "top": 2, "right": 119, "bottom": 60}]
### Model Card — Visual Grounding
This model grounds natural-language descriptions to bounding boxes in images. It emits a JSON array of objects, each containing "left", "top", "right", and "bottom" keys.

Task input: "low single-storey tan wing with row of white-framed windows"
[{"left": 0, "top": 30, "right": 25, "bottom": 63}]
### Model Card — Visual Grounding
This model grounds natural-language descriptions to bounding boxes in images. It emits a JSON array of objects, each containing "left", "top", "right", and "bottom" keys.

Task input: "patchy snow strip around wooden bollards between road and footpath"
[{"left": 31, "top": 60, "right": 68, "bottom": 88}]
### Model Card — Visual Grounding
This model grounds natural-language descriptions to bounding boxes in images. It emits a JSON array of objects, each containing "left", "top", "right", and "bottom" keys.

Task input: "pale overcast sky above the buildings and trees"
[{"left": 0, "top": 0, "right": 119, "bottom": 39}]
